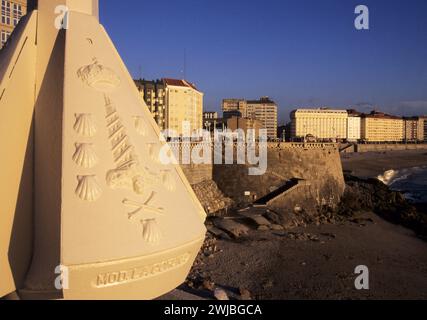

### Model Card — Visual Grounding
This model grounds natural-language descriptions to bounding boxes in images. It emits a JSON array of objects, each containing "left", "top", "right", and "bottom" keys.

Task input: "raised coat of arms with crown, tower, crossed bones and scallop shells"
[{"left": 77, "top": 58, "right": 175, "bottom": 244}]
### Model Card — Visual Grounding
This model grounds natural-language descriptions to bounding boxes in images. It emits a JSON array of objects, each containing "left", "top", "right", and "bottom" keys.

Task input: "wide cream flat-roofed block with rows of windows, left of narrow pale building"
[{"left": 291, "top": 108, "right": 348, "bottom": 140}]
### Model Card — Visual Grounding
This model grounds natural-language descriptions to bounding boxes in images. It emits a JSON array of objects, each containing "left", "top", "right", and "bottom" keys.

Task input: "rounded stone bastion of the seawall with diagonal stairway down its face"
[{"left": 213, "top": 143, "right": 345, "bottom": 213}]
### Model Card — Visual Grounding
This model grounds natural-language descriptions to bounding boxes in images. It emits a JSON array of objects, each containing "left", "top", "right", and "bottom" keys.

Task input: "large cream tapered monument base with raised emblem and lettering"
[{"left": 0, "top": 0, "right": 206, "bottom": 299}]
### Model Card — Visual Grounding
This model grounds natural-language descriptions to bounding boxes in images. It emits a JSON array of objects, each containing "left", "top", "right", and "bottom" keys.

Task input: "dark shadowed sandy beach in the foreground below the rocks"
[{"left": 186, "top": 213, "right": 427, "bottom": 299}]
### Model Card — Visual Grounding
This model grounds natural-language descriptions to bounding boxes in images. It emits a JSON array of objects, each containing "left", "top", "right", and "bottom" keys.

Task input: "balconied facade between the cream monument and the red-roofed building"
[{"left": 135, "top": 80, "right": 167, "bottom": 130}]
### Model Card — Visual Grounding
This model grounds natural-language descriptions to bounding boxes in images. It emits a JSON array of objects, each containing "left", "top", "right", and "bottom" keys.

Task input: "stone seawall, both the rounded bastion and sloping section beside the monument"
[{"left": 174, "top": 143, "right": 345, "bottom": 215}]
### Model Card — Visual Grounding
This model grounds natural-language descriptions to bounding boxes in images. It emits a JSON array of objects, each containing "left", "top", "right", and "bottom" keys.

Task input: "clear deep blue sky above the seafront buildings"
[{"left": 100, "top": 0, "right": 427, "bottom": 123}]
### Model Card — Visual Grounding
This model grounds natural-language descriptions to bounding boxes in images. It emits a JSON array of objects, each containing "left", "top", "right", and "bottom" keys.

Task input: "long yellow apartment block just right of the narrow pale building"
[{"left": 362, "top": 111, "right": 404, "bottom": 142}]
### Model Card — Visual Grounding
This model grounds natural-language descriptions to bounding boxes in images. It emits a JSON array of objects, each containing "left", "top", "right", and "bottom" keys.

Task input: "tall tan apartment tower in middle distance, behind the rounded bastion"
[{"left": 243, "top": 97, "right": 277, "bottom": 139}]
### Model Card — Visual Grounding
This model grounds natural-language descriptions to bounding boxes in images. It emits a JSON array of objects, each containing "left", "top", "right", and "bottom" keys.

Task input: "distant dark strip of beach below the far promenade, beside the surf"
[{"left": 341, "top": 150, "right": 427, "bottom": 178}]
